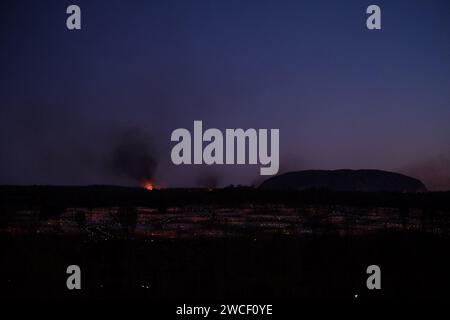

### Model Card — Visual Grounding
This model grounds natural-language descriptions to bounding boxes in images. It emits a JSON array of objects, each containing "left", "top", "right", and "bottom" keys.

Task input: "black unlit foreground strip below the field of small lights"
[{"left": 0, "top": 233, "right": 450, "bottom": 301}]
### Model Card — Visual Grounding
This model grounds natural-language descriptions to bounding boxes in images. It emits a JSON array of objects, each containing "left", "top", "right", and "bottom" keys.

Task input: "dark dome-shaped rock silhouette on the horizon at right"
[{"left": 260, "top": 169, "right": 427, "bottom": 192}]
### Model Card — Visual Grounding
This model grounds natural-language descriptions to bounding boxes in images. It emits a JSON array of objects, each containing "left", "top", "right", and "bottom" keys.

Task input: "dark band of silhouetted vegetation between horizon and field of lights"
[{"left": 0, "top": 186, "right": 450, "bottom": 215}]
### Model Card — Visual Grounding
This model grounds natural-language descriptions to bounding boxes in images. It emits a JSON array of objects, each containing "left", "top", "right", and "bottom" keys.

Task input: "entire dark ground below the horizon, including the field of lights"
[{"left": 0, "top": 187, "right": 450, "bottom": 303}]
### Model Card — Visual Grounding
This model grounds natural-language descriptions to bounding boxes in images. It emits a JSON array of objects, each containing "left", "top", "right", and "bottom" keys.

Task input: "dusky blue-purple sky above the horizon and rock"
[{"left": 0, "top": 0, "right": 450, "bottom": 190}]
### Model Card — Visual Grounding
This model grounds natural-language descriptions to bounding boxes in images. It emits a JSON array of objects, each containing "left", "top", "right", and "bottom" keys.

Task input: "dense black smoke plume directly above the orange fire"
[{"left": 109, "top": 129, "right": 158, "bottom": 184}]
